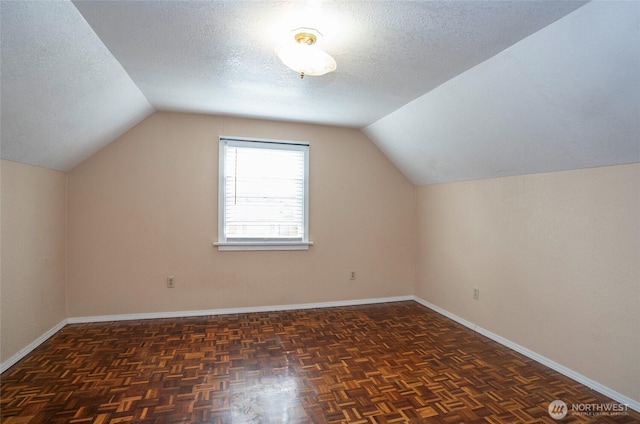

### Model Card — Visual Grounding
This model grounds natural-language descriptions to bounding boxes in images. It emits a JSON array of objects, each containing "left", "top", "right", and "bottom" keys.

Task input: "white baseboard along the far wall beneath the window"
[{"left": 68, "top": 296, "right": 414, "bottom": 324}]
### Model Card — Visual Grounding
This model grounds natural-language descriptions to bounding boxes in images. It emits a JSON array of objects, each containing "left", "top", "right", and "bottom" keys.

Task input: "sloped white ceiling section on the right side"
[{"left": 363, "top": 2, "right": 640, "bottom": 185}]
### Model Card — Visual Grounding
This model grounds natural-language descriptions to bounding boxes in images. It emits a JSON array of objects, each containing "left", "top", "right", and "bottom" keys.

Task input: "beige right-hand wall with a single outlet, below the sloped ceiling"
[{"left": 416, "top": 164, "right": 640, "bottom": 399}]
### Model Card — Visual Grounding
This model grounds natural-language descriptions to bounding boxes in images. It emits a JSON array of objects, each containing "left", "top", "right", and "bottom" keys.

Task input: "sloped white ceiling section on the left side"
[{"left": 0, "top": 1, "right": 154, "bottom": 171}]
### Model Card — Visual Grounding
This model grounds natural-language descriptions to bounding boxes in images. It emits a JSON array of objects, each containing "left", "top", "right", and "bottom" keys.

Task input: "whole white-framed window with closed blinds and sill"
[{"left": 214, "top": 137, "right": 312, "bottom": 250}]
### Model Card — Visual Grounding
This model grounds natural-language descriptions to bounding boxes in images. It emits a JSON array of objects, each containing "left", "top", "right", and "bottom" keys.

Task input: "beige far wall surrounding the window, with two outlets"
[{"left": 68, "top": 113, "right": 415, "bottom": 317}]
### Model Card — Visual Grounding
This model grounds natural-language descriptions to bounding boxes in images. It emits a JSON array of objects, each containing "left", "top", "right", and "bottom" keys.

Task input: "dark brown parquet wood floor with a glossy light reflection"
[{"left": 0, "top": 302, "right": 640, "bottom": 424}]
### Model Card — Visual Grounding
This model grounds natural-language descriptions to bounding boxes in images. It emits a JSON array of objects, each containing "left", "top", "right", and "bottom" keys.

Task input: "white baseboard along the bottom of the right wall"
[{"left": 413, "top": 296, "right": 640, "bottom": 412}]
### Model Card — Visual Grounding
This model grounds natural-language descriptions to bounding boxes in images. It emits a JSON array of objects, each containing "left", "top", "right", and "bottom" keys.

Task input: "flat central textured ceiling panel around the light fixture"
[{"left": 74, "top": 0, "right": 580, "bottom": 128}]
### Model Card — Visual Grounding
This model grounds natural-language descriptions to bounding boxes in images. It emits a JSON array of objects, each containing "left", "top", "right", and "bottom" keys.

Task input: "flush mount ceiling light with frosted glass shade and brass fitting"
[{"left": 276, "top": 28, "right": 336, "bottom": 78}]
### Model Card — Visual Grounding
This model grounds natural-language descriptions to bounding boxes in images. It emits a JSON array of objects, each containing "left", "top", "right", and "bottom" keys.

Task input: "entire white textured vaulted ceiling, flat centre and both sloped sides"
[{"left": 0, "top": 0, "right": 640, "bottom": 184}]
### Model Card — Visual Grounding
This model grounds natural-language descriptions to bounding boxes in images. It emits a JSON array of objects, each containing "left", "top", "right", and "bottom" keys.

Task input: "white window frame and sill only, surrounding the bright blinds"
[{"left": 213, "top": 136, "right": 313, "bottom": 251}]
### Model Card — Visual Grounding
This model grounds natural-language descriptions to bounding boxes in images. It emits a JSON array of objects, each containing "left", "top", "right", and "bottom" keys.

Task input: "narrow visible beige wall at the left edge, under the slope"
[{"left": 0, "top": 160, "right": 67, "bottom": 363}]
